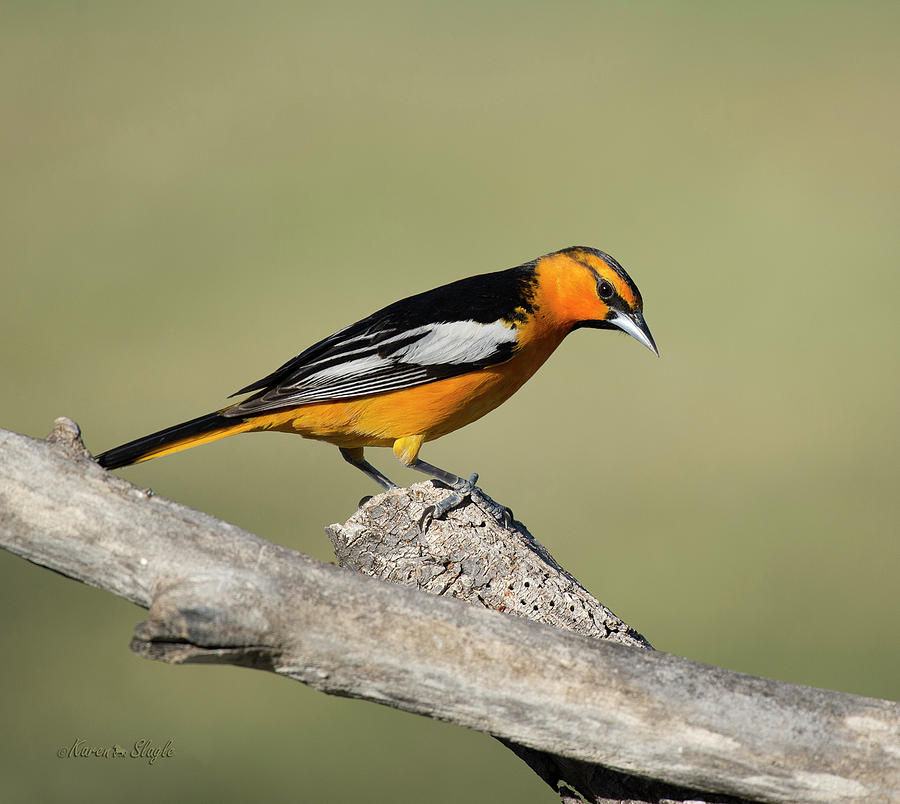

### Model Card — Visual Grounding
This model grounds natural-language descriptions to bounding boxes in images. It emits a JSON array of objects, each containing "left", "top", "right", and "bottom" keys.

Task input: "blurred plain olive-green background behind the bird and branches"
[{"left": 0, "top": 2, "right": 900, "bottom": 802}]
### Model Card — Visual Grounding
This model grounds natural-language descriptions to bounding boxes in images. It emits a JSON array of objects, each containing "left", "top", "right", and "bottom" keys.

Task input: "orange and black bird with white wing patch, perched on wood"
[{"left": 97, "top": 246, "right": 659, "bottom": 520}]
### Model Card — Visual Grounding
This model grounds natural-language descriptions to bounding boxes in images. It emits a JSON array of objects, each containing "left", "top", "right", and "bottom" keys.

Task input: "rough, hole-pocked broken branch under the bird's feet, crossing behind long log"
[{"left": 326, "top": 484, "right": 745, "bottom": 804}]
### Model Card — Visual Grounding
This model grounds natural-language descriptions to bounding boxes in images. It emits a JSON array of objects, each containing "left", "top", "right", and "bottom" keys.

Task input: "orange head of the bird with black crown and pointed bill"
[{"left": 535, "top": 246, "right": 659, "bottom": 357}]
